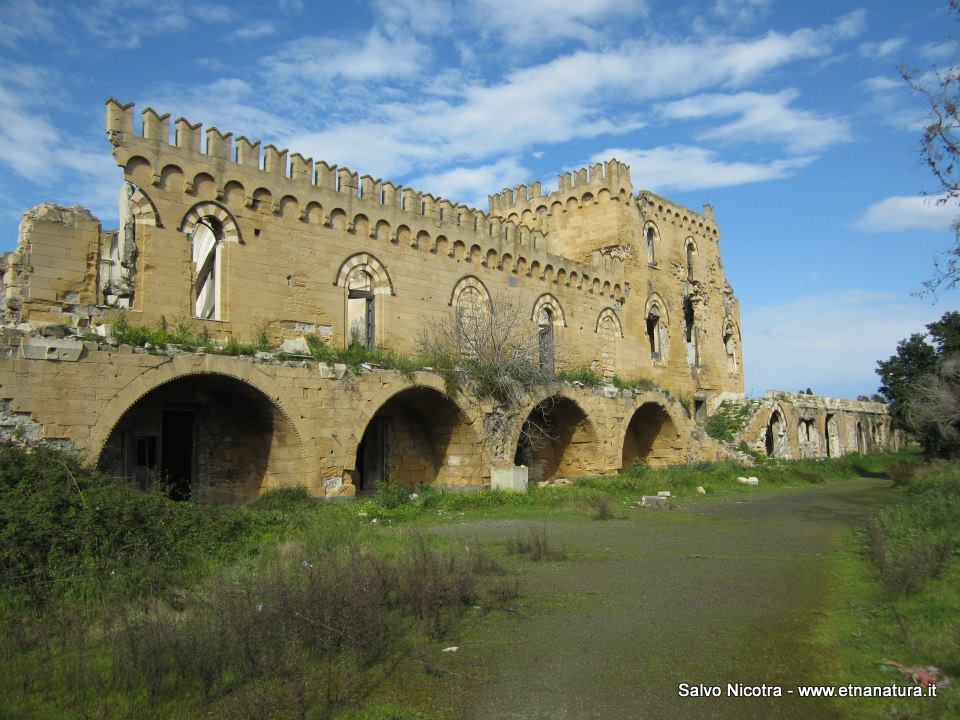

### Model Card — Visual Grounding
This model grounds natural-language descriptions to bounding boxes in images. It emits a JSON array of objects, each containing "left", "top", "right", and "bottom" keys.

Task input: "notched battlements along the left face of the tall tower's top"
[{"left": 488, "top": 158, "right": 633, "bottom": 222}]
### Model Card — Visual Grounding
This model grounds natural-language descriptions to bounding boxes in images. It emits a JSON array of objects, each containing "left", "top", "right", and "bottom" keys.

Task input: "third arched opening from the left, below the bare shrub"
[{"left": 513, "top": 395, "right": 597, "bottom": 482}]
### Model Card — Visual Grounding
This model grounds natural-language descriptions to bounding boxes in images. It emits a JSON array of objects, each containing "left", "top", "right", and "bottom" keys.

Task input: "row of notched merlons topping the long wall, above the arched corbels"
[{"left": 105, "top": 98, "right": 625, "bottom": 300}]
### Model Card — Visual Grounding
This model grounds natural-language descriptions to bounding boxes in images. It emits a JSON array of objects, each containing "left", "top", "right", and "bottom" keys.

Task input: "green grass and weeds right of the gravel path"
[{"left": 820, "top": 463, "right": 960, "bottom": 720}]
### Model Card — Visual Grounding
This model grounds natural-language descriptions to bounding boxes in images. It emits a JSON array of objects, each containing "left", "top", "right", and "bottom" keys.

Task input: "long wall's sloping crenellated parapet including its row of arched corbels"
[{"left": 106, "top": 98, "right": 629, "bottom": 302}]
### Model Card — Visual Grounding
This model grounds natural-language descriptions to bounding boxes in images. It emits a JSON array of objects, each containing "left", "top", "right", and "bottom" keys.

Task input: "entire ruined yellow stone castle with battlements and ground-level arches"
[{"left": 0, "top": 99, "right": 898, "bottom": 501}]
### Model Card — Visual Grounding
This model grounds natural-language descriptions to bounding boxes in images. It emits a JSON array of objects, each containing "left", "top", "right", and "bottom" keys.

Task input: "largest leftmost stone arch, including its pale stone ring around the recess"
[{"left": 87, "top": 355, "right": 317, "bottom": 502}]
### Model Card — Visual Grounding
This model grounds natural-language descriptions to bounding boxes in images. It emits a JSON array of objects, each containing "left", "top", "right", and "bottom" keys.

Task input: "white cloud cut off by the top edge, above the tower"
[{"left": 468, "top": 0, "right": 648, "bottom": 47}]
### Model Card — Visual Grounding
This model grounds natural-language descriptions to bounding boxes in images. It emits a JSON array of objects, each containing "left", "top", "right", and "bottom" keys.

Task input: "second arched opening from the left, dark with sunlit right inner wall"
[{"left": 355, "top": 387, "right": 480, "bottom": 493}]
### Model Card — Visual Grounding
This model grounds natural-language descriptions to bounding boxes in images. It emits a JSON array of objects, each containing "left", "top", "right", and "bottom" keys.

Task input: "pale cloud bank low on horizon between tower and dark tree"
[{"left": 741, "top": 290, "right": 943, "bottom": 397}]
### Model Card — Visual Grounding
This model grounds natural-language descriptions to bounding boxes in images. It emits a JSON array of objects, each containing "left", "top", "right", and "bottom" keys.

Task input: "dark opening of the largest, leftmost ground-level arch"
[{"left": 98, "top": 373, "right": 302, "bottom": 502}]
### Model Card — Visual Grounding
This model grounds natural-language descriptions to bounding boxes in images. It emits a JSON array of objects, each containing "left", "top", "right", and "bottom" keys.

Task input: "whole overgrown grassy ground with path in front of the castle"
[{"left": 0, "top": 448, "right": 960, "bottom": 720}]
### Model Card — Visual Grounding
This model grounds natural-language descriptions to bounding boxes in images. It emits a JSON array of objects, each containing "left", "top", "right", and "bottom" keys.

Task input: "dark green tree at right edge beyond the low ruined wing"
[{"left": 877, "top": 311, "right": 960, "bottom": 456}]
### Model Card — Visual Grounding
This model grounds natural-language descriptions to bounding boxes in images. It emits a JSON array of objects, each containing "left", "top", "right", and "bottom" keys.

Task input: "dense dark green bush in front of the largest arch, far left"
[{"left": 0, "top": 446, "right": 258, "bottom": 603}]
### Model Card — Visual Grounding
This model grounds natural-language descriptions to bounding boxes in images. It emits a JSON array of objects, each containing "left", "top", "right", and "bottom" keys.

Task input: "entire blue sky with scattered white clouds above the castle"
[{"left": 0, "top": 0, "right": 960, "bottom": 396}]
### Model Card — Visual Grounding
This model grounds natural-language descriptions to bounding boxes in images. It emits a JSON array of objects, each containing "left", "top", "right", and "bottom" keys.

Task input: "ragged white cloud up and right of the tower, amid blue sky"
[{"left": 660, "top": 89, "right": 850, "bottom": 154}]
